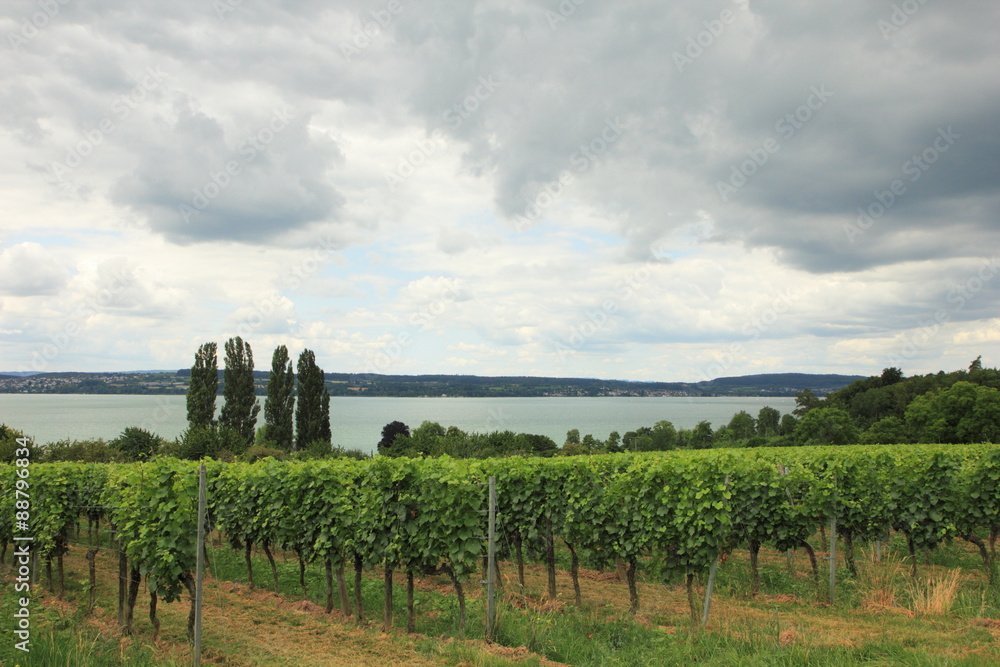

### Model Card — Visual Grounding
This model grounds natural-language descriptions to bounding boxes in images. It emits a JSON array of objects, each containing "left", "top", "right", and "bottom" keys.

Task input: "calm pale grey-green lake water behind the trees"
[{"left": 0, "top": 394, "right": 795, "bottom": 451}]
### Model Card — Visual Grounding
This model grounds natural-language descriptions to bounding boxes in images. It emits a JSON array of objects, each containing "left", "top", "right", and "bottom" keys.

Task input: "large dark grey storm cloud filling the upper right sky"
[{"left": 368, "top": 2, "right": 1000, "bottom": 272}]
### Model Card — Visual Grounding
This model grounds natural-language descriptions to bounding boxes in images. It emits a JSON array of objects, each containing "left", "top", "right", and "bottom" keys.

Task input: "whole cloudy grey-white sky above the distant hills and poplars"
[{"left": 0, "top": 0, "right": 1000, "bottom": 381}]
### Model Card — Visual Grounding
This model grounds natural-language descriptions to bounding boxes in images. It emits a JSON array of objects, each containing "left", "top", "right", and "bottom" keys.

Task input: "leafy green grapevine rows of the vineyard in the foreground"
[{"left": 0, "top": 445, "right": 1000, "bottom": 664}]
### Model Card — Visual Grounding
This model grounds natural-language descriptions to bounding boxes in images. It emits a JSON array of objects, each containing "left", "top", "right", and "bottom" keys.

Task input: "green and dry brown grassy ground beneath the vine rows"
[{"left": 0, "top": 539, "right": 1000, "bottom": 667}]
